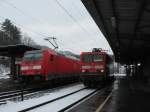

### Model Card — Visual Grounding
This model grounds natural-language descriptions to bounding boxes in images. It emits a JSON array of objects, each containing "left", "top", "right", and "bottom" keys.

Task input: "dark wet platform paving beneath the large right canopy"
[{"left": 100, "top": 77, "right": 150, "bottom": 112}]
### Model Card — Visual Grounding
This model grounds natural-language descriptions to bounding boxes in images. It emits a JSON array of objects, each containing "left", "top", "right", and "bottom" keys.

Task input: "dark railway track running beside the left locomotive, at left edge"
[{"left": 0, "top": 83, "right": 82, "bottom": 105}]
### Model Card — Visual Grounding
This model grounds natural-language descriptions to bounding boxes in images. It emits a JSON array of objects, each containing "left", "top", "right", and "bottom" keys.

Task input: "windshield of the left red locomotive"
[{"left": 23, "top": 52, "right": 43, "bottom": 61}]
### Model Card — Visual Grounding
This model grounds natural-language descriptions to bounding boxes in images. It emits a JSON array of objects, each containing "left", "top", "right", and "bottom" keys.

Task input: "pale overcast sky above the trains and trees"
[{"left": 0, "top": 0, "right": 111, "bottom": 54}]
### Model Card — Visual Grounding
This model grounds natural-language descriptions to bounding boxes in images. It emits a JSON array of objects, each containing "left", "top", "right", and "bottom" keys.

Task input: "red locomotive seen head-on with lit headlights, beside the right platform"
[{"left": 80, "top": 48, "right": 113, "bottom": 87}]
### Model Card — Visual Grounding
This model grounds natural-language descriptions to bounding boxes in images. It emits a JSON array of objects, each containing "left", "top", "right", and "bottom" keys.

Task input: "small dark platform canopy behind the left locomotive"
[{"left": 0, "top": 44, "right": 38, "bottom": 58}]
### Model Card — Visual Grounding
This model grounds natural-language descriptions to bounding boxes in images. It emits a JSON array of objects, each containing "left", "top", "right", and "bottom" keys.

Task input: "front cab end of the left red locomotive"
[{"left": 21, "top": 50, "right": 55, "bottom": 80}]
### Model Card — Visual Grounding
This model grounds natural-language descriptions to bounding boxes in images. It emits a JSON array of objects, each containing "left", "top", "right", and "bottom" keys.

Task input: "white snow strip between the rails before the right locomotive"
[{"left": 29, "top": 89, "right": 94, "bottom": 112}]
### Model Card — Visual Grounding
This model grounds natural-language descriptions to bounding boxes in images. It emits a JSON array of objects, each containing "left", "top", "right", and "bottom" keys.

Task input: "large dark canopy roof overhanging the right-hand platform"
[{"left": 82, "top": 0, "right": 150, "bottom": 64}]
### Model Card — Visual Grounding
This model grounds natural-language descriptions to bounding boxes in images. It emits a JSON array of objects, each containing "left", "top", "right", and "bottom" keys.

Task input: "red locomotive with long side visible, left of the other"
[{"left": 21, "top": 49, "right": 81, "bottom": 80}]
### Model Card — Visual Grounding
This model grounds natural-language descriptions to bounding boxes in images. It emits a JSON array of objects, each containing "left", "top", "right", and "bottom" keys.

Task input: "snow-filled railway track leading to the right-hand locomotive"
[{"left": 19, "top": 88, "right": 106, "bottom": 112}]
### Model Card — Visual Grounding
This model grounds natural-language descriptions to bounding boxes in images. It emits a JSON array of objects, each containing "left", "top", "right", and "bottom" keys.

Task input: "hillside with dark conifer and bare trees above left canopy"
[{"left": 0, "top": 19, "right": 36, "bottom": 46}]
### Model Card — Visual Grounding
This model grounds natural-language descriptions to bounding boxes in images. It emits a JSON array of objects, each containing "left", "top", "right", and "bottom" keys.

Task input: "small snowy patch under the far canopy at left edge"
[{"left": 0, "top": 65, "right": 10, "bottom": 79}]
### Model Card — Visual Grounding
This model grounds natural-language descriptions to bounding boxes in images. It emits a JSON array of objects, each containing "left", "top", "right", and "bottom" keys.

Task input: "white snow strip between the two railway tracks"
[{"left": 0, "top": 84, "right": 84, "bottom": 112}]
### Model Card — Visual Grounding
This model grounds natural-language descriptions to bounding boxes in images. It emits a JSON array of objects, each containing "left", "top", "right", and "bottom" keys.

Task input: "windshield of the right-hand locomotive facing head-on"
[{"left": 82, "top": 54, "right": 103, "bottom": 63}]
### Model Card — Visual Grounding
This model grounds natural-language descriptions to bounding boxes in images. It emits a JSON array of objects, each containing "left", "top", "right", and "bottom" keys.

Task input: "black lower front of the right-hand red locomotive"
[{"left": 80, "top": 73, "right": 110, "bottom": 88}]
